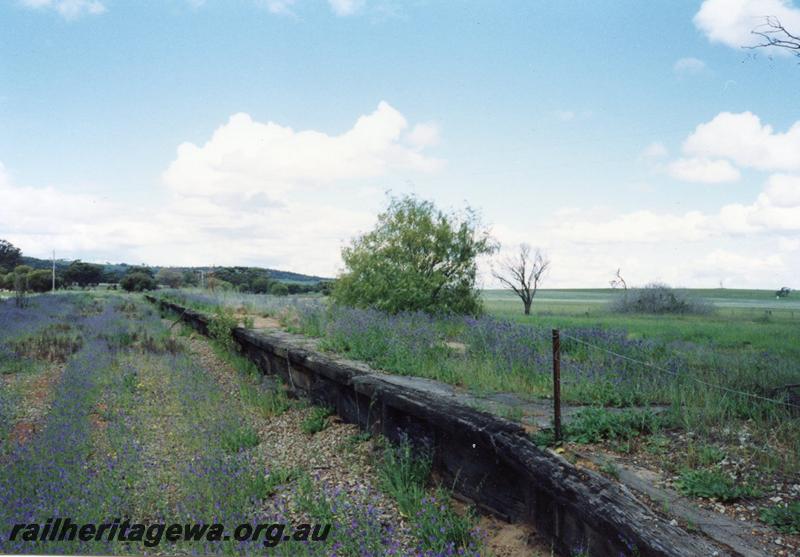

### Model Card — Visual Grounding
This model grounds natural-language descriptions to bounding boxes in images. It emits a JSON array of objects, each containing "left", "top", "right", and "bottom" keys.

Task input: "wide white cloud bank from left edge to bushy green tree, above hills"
[{"left": 0, "top": 103, "right": 441, "bottom": 275}]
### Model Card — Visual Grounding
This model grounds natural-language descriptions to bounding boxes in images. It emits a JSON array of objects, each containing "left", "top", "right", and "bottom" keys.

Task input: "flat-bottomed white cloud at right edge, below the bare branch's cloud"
[{"left": 683, "top": 112, "right": 800, "bottom": 172}]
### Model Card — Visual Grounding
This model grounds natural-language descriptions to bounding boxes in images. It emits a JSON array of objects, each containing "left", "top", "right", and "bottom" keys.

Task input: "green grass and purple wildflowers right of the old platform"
[{"left": 158, "top": 289, "right": 800, "bottom": 473}]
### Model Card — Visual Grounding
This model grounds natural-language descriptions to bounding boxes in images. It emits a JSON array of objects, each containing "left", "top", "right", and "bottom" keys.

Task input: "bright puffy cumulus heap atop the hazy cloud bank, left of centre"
[{"left": 164, "top": 102, "right": 442, "bottom": 197}]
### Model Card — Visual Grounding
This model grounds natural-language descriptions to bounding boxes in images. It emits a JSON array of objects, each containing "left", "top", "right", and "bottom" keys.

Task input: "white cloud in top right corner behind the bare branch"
[{"left": 694, "top": 0, "right": 800, "bottom": 53}]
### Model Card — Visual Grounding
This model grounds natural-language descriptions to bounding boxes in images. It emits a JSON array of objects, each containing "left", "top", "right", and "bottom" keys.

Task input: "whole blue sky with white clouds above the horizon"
[{"left": 0, "top": 0, "right": 800, "bottom": 289}]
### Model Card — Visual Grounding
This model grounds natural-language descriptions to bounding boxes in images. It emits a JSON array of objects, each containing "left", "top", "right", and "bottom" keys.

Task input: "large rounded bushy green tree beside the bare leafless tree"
[{"left": 332, "top": 196, "right": 496, "bottom": 315}]
